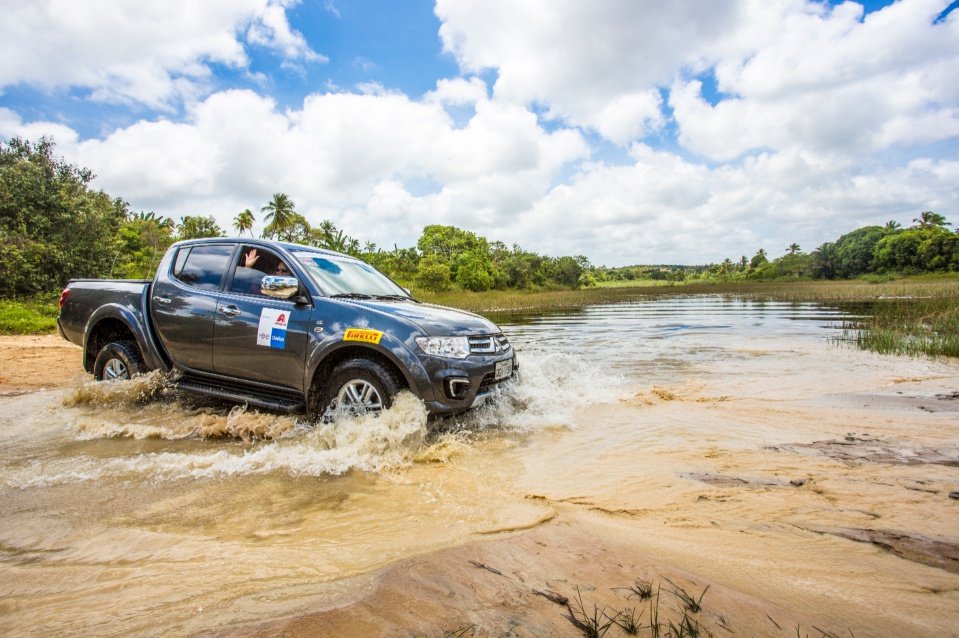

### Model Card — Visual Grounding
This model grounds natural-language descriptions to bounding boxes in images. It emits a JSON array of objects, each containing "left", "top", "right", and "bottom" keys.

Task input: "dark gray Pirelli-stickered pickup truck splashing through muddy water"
[{"left": 57, "top": 238, "right": 517, "bottom": 419}]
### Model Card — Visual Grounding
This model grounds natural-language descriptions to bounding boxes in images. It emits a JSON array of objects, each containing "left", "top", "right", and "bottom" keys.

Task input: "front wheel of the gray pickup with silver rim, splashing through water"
[{"left": 313, "top": 359, "right": 401, "bottom": 422}]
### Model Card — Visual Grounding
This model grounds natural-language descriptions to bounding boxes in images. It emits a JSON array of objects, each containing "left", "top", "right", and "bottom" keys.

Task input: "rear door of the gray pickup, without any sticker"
[{"left": 150, "top": 244, "right": 235, "bottom": 372}]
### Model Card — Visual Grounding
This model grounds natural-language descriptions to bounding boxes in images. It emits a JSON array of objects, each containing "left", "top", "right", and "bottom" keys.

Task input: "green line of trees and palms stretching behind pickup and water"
[{"left": 0, "top": 138, "right": 959, "bottom": 297}]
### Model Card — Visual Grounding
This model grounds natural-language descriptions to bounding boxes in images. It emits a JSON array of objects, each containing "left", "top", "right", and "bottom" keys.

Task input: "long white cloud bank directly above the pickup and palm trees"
[{"left": 0, "top": 90, "right": 587, "bottom": 258}]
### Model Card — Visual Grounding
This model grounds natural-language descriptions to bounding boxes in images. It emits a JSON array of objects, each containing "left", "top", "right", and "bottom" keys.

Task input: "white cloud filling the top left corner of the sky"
[{"left": 0, "top": 0, "right": 323, "bottom": 108}]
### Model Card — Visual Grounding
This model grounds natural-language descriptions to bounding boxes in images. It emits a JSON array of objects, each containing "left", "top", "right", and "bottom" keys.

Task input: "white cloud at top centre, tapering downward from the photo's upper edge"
[{"left": 436, "top": 0, "right": 739, "bottom": 143}]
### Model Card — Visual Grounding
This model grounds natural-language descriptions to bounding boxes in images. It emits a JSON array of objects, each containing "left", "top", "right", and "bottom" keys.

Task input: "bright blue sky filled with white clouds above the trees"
[{"left": 0, "top": 0, "right": 959, "bottom": 266}]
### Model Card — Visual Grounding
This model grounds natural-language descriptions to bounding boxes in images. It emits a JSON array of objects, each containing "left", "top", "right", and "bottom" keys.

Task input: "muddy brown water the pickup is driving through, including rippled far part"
[{"left": 0, "top": 297, "right": 959, "bottom": 636}]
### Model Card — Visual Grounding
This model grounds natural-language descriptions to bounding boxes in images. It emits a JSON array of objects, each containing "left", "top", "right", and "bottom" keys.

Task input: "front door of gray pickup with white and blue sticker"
[{"left": 213, "top": 246, "right": 313, "bottom": 391}]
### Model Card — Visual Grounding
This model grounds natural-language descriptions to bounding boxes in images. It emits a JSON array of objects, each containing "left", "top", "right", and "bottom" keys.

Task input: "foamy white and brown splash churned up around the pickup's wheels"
[{"left": 3, "top": 354, "right": 625, "bottom": 487}]
